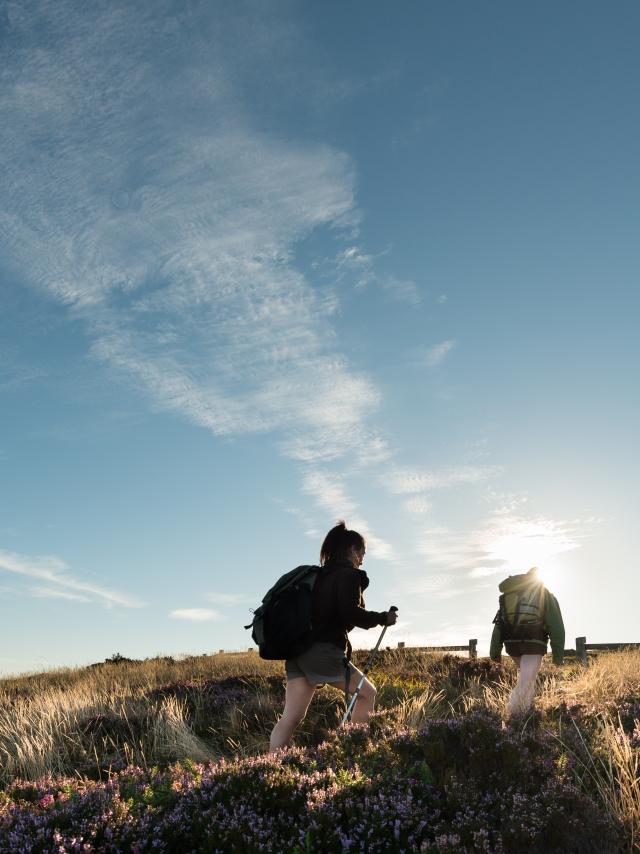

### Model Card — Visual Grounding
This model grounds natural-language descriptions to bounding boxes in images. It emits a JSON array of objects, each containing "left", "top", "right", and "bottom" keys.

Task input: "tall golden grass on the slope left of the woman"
[{"left": 0, "top": 653, "right": 282, "bottom": 785}]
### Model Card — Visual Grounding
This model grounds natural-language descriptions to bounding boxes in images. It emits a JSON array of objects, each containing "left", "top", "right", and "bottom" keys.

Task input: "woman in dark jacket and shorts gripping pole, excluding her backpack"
[{"left": 270, "top": 522, "right": 397, "bottom": 751}]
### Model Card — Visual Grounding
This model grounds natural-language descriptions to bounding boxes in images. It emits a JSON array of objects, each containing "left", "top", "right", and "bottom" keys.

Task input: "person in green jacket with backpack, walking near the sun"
[{"left": 489, "top": 566, "right": 564, "bottom": 720}]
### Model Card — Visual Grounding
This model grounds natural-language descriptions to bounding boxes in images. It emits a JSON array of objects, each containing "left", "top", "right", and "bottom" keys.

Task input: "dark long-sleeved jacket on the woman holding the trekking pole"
[{"left": 311, "top": 561, "right": 387, "bottom": 655}]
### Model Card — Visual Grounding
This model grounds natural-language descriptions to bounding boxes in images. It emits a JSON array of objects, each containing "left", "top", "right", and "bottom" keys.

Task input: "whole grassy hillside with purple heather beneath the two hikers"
[{"left": 0, "top": 650, "right": 640, "bottom": 854}]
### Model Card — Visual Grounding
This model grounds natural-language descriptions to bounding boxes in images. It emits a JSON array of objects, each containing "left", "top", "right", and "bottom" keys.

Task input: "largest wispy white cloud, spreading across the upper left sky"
[{"left": 0, "top": 0, "right": 379, "bottom": 462}]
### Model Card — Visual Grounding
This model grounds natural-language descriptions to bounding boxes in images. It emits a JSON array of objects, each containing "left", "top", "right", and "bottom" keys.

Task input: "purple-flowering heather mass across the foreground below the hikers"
[{"left": 0, "top": 715, "right": 620, "bottom": 854}]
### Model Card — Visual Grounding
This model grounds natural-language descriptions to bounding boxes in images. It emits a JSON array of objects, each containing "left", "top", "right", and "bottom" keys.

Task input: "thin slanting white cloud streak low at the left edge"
[{"left": 0, "top": 551, "right": 143, "bottom": 608}]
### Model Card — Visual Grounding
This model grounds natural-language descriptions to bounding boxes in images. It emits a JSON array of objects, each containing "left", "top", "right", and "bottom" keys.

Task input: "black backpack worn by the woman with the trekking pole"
[{"left": 245, "top": 566, "right": 320, "bottom": 661}]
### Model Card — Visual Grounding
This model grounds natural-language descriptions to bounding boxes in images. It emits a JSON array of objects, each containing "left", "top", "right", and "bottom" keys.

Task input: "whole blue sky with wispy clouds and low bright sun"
[{"left": 0, "top": 0, "right": 640, "bottom": 672}]
